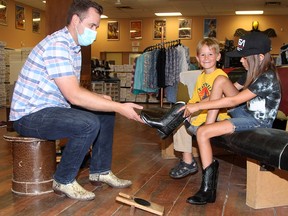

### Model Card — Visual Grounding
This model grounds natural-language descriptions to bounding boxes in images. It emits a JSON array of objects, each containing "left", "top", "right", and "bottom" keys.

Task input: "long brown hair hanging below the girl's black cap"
[{"left": 244, "top": 52, "right": 280, "bottom": 88}]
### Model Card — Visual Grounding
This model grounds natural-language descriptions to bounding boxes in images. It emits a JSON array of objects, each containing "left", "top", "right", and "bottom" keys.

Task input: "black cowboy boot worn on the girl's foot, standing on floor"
[{"left": 187, "top": 160, "right": 219, "bottom": 205}]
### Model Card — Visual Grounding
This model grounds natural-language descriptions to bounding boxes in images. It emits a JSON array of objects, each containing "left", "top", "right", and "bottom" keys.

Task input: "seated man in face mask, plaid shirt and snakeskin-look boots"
[{"left": 10, "top": 0, "right": 142, "bottom": 200}]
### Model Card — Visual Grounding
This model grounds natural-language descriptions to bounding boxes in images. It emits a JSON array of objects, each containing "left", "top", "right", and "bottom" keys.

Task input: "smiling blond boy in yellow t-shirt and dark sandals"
[{"left": 169, "top": 38, "right": 229, "bottom": 179}]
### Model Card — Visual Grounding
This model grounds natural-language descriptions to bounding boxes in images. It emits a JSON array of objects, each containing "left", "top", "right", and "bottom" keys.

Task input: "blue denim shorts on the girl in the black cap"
[{"left": 227, "top": 104, "right": 272, "bottom": 131}]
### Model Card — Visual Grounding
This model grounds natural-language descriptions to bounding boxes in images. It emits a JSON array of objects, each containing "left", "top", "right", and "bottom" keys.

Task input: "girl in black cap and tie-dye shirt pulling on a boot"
[{"left": 182, "top": 32, "right": 281, "bottom": 205}]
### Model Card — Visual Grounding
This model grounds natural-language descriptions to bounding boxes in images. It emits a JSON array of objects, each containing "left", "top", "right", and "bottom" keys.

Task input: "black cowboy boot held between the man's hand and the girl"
[{"left": 140, "top": 102, "right": 185, "bottom": 139}]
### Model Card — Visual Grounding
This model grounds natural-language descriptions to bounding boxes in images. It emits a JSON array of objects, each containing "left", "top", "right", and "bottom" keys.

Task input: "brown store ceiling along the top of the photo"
[{"left": 16, "top": 0, "right": 288, "bottom": 19}]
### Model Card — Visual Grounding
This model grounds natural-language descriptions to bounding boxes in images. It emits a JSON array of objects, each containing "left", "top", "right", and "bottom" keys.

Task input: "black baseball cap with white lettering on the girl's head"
[{"left": 226, "top": 32, "right": 271, "bottom": 57}]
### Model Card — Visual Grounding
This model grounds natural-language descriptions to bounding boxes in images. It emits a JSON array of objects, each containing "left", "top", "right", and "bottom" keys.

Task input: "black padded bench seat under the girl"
[{"left": 211, "top": 128, "right": 288, "bottom": 170}]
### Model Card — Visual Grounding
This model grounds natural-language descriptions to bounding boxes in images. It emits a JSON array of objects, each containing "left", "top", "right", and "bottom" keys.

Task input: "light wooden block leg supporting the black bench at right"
[{"left": 246, "top": 160, "right": 288, "bottom": 209}]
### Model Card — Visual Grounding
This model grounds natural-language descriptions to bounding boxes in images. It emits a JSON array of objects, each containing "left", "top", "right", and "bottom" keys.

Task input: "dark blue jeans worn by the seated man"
[{"left": 13, "top": 107, "right": 115, "bottom": 184}]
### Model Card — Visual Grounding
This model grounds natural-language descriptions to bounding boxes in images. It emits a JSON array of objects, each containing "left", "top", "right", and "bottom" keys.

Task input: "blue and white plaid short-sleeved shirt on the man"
[{"left": 10, "top": 27, "right": 81, "bottom": 121}]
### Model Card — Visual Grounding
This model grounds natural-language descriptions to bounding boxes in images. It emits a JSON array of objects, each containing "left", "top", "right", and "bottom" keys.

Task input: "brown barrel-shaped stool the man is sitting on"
[{"left": 3, "top": 132, "right": 56, "bottom": 195}]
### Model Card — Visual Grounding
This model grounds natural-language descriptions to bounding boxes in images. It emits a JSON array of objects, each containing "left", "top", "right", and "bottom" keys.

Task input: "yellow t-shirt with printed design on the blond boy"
[{"left": 188, "top": 69, "right": 230, "bottom": 126}]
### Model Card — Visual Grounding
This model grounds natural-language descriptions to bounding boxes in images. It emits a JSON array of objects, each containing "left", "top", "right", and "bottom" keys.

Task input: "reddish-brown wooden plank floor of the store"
[{"left": 0, "top": 105, "right": 288, "bottom": 216}]
